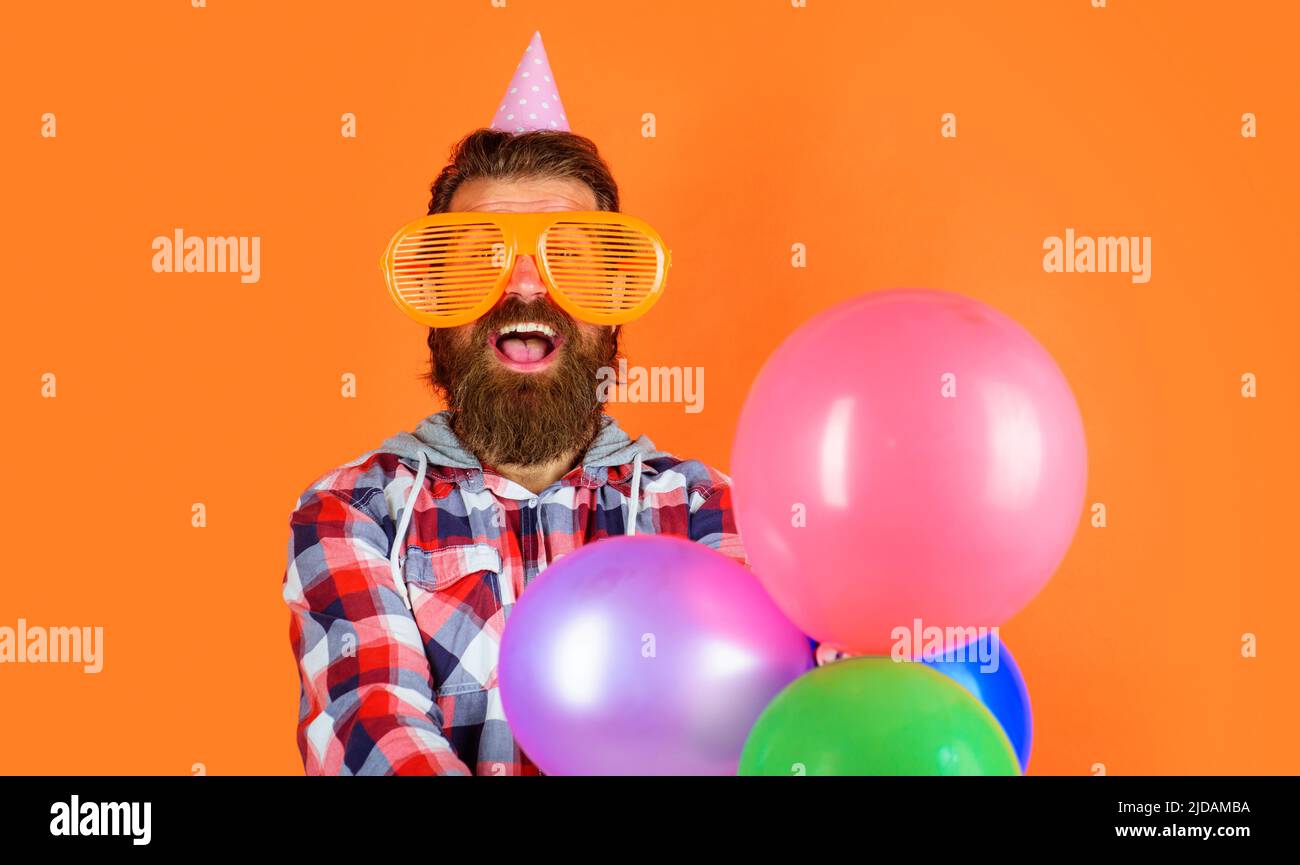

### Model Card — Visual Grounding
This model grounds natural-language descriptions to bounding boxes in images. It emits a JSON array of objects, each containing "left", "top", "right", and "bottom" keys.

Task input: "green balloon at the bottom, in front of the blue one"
[{"left": 740, "top": 658, "right": 1021, "bottom": 775}]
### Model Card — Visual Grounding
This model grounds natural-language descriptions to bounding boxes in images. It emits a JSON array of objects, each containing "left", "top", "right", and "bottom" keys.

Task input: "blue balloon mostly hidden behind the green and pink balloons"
[{"left": 923, "top": 632, "right": 1034, "bottom": 773}]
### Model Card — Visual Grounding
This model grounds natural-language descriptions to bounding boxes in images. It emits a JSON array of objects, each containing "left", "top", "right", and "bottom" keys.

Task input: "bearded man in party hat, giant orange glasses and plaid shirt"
[{"left": 283, "top": 34, "right": 745, "bottom": 775}]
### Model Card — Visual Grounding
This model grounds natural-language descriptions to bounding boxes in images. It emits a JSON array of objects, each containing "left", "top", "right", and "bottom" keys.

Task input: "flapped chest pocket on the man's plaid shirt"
[{"left": 403, "top": 544, "right": 502, "bottom": 697}]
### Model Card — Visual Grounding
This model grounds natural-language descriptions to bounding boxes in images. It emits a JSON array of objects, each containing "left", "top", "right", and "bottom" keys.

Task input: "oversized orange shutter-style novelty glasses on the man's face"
[{"left": 380, "top": 211, "right": 672, "bottom": 328}]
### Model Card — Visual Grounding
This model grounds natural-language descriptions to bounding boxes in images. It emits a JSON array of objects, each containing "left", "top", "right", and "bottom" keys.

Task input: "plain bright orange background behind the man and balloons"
[{"left": 0, "top": 0, "right": 1300, "bottom": 774}]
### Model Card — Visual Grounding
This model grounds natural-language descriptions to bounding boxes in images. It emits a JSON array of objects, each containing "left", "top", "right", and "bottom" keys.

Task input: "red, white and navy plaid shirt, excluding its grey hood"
[{"left": 283, "top": 413, "right": 748, "bottom": 775}]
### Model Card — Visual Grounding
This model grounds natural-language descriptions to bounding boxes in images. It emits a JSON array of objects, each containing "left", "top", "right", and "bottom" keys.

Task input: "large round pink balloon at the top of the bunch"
[{"left": 732, "top": 289, "right": 1087, "bottom": 654}]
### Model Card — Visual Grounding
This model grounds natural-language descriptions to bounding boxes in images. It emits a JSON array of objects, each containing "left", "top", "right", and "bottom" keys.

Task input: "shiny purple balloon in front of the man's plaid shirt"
[{"left": 498, "top": 535, "right": 813, "bottom": 775}]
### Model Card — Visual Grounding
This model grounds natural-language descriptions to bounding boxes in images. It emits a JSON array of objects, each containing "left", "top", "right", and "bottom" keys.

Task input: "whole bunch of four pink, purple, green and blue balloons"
[{"left": 498, "top": 290, "right": 1087, "bottom": 775}]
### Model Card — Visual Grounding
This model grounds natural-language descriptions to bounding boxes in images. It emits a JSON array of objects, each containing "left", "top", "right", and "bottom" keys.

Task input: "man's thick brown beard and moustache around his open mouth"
[{"left": 429, "top": 297, "right": 619, "bottom": 466}]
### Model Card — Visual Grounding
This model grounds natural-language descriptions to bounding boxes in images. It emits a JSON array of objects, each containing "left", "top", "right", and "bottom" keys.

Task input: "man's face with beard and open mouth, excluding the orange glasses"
[{"left": 429, "top": 178, "right": 618, "bottom": 466}]
